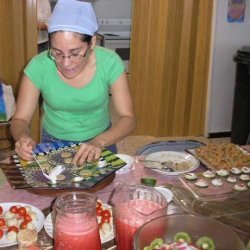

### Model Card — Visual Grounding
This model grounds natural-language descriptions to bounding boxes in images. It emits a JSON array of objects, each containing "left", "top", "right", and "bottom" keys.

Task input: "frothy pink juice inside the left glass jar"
[{"left": 54, "top": 214, "right": 102, "bottom": 250}]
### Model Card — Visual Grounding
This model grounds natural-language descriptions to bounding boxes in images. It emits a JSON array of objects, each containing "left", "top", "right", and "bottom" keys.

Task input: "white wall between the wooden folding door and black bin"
[{"left": 207, "top": 0, "right": 250, "bottom": 133}]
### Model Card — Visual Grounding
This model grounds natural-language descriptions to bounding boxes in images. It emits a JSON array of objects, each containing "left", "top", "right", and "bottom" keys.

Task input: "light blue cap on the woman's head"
[{"left": 48, "top": 0, "right": 98, "bottom": 36}]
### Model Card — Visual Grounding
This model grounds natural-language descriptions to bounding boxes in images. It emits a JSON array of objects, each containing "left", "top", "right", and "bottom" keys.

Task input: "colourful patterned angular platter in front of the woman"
[{"left": 2, "top": 143, "right": 126, "bottom": 193}]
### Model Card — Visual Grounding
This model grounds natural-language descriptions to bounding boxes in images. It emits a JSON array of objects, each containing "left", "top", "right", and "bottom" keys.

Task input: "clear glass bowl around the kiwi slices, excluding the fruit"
[{"left": 134, "top": 214, "right": 246, "bottom": 250}]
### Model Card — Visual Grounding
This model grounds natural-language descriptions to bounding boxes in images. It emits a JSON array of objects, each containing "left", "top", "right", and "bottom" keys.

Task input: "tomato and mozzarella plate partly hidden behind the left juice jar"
[{"left": 44, "top": 200, "right": 114, "bottom": 243}]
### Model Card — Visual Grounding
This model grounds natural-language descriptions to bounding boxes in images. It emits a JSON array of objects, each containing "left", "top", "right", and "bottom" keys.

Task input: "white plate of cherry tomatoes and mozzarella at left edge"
[{"left": 0, "top": 202, "right": 44, "bottom": 248}]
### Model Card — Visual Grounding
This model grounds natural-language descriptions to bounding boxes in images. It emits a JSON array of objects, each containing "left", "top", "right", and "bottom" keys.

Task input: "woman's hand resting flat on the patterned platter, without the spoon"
[{"left": 73, "top": 141, "right": 102, "bottom": 165}]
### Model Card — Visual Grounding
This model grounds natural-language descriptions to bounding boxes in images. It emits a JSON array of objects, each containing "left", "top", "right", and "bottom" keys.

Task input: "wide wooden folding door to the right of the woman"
[{"left": 130, "top": 0, "right": 213, "bottom": 136}]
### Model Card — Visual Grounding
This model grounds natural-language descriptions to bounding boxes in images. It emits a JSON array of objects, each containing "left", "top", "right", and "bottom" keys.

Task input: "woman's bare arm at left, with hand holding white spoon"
[{"left": 10, "top": 75, "right": 40, "bottom": 160}]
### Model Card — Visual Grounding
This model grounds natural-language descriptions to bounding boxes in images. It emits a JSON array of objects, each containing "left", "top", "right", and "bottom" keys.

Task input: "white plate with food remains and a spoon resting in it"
[{"left": 145, "top": 151, "right": 200, "bottom": 175}]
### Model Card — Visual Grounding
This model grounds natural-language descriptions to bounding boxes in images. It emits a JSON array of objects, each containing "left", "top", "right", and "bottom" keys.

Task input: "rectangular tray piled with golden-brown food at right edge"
[{"left": 188, "top": 143, "right": 250, "bottom": 173}]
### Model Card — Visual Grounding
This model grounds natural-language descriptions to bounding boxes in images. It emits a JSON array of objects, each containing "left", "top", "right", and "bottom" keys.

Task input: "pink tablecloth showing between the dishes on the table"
[{"left": 0, "top": 152, "right": 250, "bottom": 250}]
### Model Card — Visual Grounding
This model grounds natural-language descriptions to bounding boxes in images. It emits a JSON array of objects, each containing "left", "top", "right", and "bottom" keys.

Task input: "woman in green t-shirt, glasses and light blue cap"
[{"left": 11, "top": 0, "right": 135, "bottom": 164}]
